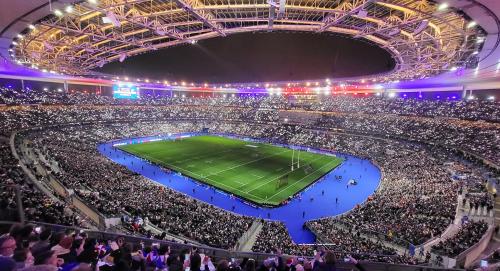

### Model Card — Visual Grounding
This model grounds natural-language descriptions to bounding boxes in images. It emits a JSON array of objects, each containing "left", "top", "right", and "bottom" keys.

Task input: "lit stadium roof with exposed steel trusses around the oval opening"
[{"left": 0, "top": 0, "right": 500, "bottom": 89}]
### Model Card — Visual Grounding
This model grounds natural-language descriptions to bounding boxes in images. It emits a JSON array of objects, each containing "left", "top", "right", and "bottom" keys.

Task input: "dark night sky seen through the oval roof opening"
[{"left": 100, "top": 32, "right": 394, "bottom": 83}]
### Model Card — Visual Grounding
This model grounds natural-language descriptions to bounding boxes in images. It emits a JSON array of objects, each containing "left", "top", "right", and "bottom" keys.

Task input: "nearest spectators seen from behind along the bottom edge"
[{"left": 0, "top": 224, "right": 366, "bottom": 271}]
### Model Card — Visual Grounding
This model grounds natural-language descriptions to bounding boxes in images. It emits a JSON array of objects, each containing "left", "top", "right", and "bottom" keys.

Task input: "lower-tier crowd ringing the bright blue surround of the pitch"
[{"left": 20, "top": 121, "right": 487, "bottom": 258}]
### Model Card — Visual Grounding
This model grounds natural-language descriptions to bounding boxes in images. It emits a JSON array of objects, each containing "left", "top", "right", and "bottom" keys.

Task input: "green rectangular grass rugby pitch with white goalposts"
[{"left": 119, "top": 136, "right": 342, "bottom": 206}]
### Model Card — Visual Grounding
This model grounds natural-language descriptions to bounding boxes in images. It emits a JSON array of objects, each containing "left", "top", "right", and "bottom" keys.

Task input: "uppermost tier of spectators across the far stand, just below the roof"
[{"left": 0, "top": 87, "right": 500, "bottom": 122}]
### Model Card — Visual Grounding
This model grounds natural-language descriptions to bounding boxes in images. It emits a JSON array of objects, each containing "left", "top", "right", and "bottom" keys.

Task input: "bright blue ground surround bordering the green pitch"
[{"left": 98, "top": 135, "right": 381, "bottom": 244}]
